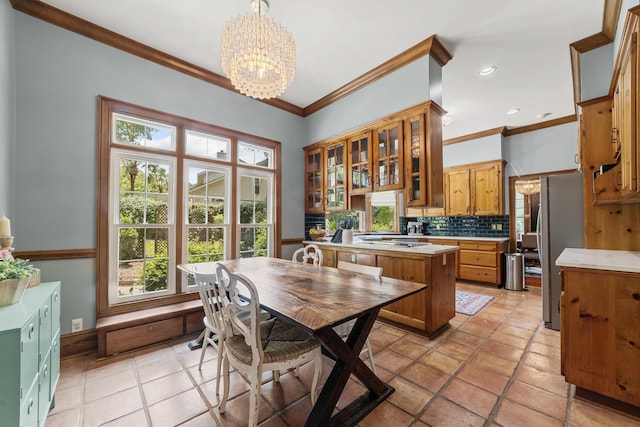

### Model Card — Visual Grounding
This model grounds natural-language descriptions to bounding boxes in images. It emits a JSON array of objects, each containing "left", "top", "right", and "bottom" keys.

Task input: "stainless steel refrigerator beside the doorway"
[{"left": 537, "top": 173, "right": 584, "bottom": 331}]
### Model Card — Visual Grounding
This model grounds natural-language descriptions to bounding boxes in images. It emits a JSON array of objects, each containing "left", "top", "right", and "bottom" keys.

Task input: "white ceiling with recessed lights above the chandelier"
[{"left": 40, "top": 0, "right": 604, "bottom": 139}]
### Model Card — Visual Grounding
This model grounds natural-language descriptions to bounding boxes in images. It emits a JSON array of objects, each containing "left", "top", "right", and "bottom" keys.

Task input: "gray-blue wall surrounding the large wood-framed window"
[{"left": 13, "top": 12, "right": 304, "bottom": 334}]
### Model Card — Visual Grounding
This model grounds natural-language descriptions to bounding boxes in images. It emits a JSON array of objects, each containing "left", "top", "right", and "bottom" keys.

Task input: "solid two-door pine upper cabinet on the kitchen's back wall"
[{"left": 444, "top": 160, "right": 504, "bottom": 216}]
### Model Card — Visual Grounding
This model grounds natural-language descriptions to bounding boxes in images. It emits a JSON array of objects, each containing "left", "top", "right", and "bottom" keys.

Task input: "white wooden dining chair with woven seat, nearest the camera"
[{"left": 216, "top": 263, "right": 323, "bottom": 426}]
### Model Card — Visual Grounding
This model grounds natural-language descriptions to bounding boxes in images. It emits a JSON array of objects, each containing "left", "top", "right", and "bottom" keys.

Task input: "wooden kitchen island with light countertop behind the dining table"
[{"left": 303, "top": 240, "right": 459, "bottom": 336}]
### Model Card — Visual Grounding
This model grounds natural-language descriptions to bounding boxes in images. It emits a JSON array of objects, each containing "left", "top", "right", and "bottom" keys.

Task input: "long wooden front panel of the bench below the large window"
[{"left": 106, "top": 317, "right": 181, "bottom": 356}]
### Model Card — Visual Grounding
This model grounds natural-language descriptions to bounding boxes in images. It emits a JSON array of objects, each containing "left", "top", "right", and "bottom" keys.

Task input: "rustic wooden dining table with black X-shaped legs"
[{"left": 178, "top": 257, "right": 426, "bottom": 426}]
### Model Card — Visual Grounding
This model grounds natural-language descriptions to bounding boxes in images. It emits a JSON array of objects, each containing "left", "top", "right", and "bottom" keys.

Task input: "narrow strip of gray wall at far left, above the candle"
[{"left": 0, "top": 1, "right": 15, "bottom": 219}]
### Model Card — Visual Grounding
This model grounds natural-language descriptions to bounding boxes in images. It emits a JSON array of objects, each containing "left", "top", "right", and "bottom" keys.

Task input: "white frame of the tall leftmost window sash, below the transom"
[{"left": 109, "top": 148, "right": 177, "bottom": 305}]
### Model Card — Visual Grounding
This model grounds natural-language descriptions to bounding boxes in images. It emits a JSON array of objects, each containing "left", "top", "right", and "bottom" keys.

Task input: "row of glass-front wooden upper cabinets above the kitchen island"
[{"left": 305, "top": 101, "right": 444, "bottom": 213}]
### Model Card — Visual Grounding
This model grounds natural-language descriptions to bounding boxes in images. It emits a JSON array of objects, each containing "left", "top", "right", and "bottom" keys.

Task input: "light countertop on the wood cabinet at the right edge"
[{"left": 556, "top": 248, "right": 640, "bottom": 273}]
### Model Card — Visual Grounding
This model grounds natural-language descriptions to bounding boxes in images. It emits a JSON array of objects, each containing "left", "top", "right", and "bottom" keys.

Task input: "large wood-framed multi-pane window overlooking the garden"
[{"left": 97, "top": 98, "right": 280, "bottom": 315}]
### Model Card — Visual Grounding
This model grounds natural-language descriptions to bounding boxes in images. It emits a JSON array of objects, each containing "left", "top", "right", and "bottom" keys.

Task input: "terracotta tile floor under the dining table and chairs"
[{"left": 46, "top": 283, "right": 640, "bottom": 427}]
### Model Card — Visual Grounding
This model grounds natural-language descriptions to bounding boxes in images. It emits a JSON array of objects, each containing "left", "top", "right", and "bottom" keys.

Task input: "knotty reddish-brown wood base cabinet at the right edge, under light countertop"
[{"left": 560, "top": 267, "right": 640, "bottom": 407}]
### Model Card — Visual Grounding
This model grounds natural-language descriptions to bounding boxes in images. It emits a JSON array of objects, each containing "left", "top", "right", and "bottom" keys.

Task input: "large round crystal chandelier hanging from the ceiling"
[{"left": 222, "top": 0, "right": 296, "bottom": 99}]
